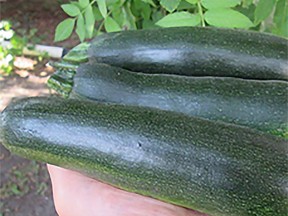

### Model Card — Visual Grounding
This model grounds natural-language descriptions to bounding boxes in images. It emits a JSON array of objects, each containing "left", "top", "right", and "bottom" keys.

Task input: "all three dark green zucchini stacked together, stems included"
[{"left": 0, "top": 27, "right": 288, "bottom": 216}]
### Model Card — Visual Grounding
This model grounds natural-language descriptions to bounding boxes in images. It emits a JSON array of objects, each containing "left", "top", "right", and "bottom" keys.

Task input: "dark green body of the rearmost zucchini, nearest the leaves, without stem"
[{"left": 88, "top": 27, "right": 288, "bottom": 80}]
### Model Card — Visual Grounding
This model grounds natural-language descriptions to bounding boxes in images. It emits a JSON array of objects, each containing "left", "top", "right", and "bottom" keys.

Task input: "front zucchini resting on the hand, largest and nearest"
[{"left": 0, "top": 98, "right": 288, "bottom": 216}]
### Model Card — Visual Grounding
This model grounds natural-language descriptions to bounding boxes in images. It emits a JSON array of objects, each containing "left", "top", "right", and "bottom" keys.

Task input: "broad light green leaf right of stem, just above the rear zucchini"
[{"left": 204, "top": 8, "right": 253, "bottom": 29}]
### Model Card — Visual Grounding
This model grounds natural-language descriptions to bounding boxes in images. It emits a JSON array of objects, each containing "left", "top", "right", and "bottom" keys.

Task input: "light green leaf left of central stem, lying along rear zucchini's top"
[{"left": 156, "top": 11, "right": 201, "bottom": 27}]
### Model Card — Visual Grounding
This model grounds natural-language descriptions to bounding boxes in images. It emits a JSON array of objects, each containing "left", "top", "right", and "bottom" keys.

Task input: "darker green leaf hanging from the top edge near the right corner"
[{"left": 254, "top": 0, "right": 276, "bottom": 25}]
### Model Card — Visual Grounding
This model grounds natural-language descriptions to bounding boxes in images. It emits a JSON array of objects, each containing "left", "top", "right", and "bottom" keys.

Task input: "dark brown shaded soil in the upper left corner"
[{"left": 0, "top": 0, "right": 79, "bottom": 48}]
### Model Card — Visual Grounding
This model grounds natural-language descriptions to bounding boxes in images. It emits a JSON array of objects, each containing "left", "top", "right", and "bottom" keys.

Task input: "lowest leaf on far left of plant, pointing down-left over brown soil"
[{"left": 54, "top": 18, "right": 75, "bottom": 42}]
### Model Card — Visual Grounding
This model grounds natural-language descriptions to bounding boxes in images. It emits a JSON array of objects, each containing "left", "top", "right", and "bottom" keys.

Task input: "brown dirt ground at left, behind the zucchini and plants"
[{"left": 0, "top": 0, "right": 79, "bottom": 216}]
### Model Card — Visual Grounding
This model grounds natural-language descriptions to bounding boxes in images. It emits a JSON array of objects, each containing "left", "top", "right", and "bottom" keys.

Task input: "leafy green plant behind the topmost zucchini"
[{"left": 55, "top": 0, "right": 288, "bottom": 42}]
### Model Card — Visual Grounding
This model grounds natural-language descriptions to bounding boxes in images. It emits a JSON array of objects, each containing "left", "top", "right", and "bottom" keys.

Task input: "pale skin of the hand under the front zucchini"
[{"left": 47, "top": 165, "right": 207, "bottom": 216}]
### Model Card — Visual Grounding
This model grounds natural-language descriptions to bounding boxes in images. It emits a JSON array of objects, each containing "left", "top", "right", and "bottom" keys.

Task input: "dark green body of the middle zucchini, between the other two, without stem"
[{"left": 70, "top": 63, "right": 288, "bottom": 139}]
